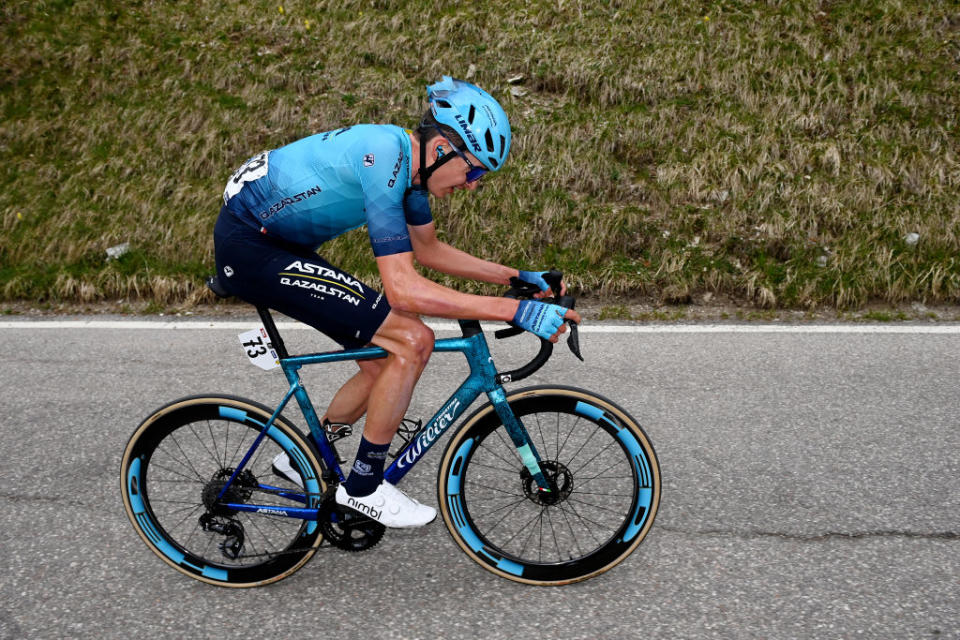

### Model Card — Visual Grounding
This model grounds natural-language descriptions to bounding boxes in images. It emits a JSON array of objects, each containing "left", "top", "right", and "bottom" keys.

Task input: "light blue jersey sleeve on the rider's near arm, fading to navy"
[{"left": 357, "top": 136, "right": 413, "bottom": 258}]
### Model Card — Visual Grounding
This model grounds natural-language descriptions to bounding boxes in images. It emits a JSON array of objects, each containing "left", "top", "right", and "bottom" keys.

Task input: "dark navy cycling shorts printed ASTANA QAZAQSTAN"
[{"left": 213, "top": 207, "right": 390, "bottom": 348}]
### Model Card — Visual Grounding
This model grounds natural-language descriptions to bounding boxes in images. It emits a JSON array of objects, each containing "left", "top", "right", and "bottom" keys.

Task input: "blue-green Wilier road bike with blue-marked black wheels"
[{"left": 120, "top": 272, "right": 661, "bottom": 587}]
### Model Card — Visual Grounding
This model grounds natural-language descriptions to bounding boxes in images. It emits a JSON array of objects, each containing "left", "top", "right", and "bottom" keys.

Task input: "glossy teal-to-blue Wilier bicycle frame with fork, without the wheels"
[{"left": 218, "top": 318, "right": 551, "bottom": 520}]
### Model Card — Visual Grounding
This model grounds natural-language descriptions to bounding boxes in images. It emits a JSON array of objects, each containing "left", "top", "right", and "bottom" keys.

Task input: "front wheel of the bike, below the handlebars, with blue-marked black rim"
[{"left": 438, "top": 387, "right": 660, "bottom": 585}]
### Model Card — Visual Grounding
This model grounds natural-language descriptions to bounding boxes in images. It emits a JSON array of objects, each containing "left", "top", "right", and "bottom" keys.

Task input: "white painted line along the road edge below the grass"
[{"left": 0, "top": 319, "right": 960, "bottom": 335}]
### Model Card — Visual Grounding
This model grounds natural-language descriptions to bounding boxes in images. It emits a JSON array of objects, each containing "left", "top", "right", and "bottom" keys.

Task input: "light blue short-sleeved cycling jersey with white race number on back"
[{"left": 223, "top": 124, "right": 433, "bottom": 256}]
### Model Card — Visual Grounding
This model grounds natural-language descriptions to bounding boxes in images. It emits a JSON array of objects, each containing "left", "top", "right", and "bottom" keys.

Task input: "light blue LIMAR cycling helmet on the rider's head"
[{"left": 427, "top": 76, "right": 510, "bottom": 171}]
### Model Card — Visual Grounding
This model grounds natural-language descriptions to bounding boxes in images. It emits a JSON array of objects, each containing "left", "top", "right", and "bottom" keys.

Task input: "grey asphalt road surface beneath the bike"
[{"left": 0, "top": 323, "right": 960, "bottom": 640}]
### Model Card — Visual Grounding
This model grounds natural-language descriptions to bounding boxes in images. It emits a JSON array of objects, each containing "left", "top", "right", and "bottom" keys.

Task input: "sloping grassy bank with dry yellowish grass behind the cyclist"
[{"left": 0, "top": 0, "right": 960, "bottom": 309}]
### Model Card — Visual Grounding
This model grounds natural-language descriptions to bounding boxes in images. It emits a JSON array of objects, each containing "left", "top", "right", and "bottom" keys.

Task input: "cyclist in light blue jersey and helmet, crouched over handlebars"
[{"left": 214, "top": 76, "right": 580, "bottom": 527}]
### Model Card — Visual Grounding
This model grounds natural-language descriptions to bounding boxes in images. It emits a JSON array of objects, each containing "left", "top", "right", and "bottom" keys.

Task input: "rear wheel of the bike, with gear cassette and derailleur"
[{"left": 120, "top": 396, "right": 325, "bottom": 587}]
